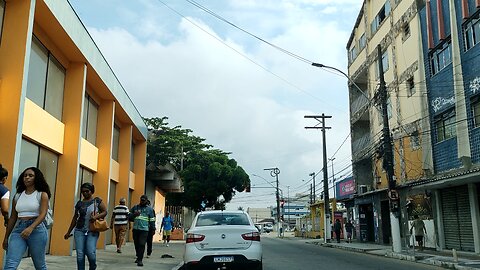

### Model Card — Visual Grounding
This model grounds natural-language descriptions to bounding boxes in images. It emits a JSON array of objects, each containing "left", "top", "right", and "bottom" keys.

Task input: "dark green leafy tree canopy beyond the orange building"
[{"left": 144, "top": 117, "right": 250, "bottom": 211}]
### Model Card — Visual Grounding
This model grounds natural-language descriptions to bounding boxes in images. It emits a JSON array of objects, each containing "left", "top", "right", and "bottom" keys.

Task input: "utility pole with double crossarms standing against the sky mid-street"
[{"left": 305, "top": 113, "right": 332, "bottom": 243}]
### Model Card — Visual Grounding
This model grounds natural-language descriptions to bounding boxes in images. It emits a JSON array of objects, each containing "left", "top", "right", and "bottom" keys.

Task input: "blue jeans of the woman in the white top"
[{"left": 3, "top": 219, "right": 48, "bottom": 270}]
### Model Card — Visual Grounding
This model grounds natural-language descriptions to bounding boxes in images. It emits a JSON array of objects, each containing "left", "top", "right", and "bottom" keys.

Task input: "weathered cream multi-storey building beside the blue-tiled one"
[{"left": 347, "top": 0, "right": 433, "bottom": 244}]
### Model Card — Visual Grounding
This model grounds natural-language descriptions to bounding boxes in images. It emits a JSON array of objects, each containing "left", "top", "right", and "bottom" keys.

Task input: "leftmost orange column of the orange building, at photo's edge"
[{"left": 0, "top": 0, "right": 35, "bottom": 265}]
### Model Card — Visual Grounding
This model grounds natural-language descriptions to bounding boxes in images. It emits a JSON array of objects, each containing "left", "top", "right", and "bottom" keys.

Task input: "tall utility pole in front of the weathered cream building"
[{"left": 377, "top": 45, "right": 402, "bottom": 253}]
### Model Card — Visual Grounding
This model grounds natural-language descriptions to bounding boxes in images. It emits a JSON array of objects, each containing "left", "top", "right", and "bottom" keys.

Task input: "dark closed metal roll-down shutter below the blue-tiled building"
[{"left": 440, "top": 185, "right": 475, "bottom": 252}]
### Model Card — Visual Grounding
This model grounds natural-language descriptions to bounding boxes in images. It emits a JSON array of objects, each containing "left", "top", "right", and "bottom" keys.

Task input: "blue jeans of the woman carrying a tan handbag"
[{"left": 73, "top": 229, "right": 100, "bottom": 270}]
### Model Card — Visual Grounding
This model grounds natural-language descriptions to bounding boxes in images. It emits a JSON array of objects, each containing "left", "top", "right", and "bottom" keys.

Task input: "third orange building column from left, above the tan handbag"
[{"left": 93, "top": 100, "right": 115, "bottom": 249}]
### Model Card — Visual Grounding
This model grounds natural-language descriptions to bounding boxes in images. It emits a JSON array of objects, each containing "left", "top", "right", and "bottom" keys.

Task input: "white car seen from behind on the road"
[{"left": 183, "top": 210, "right": 262, "bottom": 270}]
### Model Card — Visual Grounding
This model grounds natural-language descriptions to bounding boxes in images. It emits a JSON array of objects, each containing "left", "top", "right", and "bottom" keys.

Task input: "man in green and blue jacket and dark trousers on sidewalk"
[{"left": 129, "top": 194, "right": 155, "bottom": 266}]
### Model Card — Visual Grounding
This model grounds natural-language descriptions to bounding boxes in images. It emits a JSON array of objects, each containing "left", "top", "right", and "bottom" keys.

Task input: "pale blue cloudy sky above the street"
[{"left": 69, "top": 0, "right": 363, "bottom": 209}]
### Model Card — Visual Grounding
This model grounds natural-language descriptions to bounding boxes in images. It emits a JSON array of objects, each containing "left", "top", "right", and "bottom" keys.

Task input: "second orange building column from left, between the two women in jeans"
[{"left": 50, "top": 63, "right": 87, "bottom": 255}]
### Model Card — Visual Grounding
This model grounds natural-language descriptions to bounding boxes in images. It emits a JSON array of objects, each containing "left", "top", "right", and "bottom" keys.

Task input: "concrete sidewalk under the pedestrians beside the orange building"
[{"left": 18, "top": 241, "right": 185, "bottom": 270}]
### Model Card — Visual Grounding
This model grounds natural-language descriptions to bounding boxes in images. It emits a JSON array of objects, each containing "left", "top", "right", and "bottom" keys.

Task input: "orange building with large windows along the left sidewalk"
[{"left": 0, "top": 0, "right": 147, "bottom": 259}]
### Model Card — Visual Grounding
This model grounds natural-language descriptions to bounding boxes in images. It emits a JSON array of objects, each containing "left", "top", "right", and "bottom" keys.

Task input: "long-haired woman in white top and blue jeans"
[{"left": 3, "top": 167, "right": 51, "bottom": 270}]
